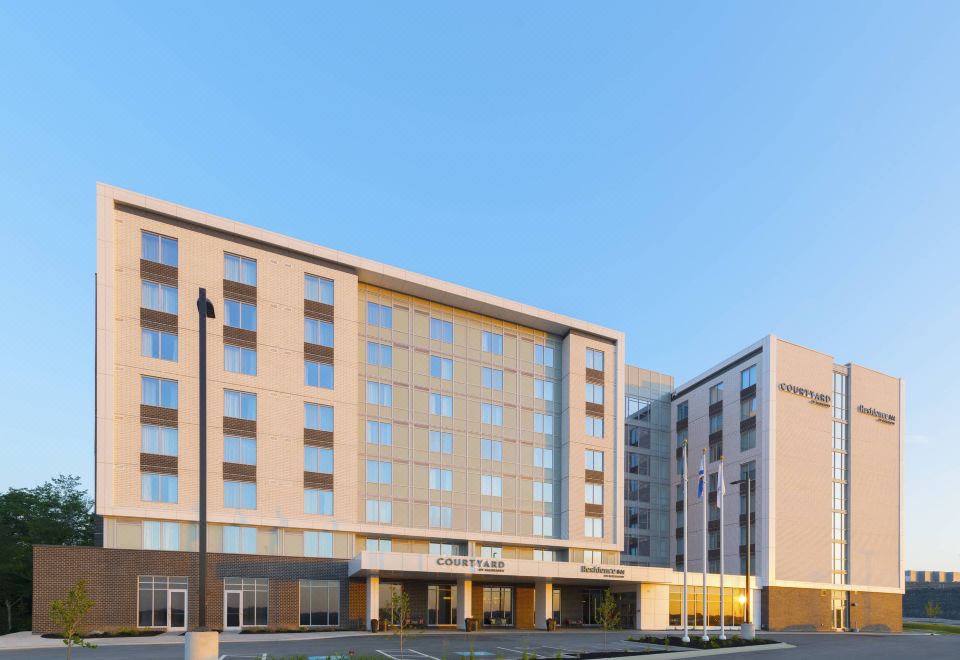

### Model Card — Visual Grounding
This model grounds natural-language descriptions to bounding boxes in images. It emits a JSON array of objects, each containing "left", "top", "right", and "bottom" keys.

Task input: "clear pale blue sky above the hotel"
[{"left": 0, "top": 1, "right": 960, "bottom": 569}]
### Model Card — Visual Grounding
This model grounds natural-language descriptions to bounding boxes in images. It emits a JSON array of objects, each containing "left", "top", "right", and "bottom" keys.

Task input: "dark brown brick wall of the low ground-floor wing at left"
[{"left": 33, "top": 545, "right": 354, "bottom": 633}]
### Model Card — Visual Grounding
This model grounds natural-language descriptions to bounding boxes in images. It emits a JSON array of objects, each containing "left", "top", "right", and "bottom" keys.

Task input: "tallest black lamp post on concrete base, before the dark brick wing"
[{"left": 184, "top": 287, "right": 220, "bottom": 660}]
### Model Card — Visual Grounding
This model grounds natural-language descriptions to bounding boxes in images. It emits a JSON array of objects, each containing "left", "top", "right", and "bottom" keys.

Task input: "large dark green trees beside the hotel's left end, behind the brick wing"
[{"left": 0, "top": 475, "right": 93, "bottom": 632}]
